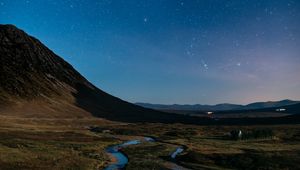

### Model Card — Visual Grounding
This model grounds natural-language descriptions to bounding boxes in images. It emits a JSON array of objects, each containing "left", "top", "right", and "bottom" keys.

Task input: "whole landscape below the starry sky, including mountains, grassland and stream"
[{"left": 0, "top": 24, "right": 300, "bottom": 170}]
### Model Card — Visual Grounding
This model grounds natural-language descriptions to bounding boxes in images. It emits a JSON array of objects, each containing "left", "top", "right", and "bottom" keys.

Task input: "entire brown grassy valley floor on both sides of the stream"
[{"left": 0, "top": 116, "right": 300, "bottom": 169}]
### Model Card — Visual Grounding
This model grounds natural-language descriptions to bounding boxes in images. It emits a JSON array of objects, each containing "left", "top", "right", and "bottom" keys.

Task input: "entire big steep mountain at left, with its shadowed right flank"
[{"left": 0, "top": 25, "right": 202, "bottom": 122}]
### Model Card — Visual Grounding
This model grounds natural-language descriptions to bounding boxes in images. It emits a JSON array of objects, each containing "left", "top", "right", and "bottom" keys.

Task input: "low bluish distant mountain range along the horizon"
[{"left": 136, "top": 100, "right": 300, "bottom": 111}]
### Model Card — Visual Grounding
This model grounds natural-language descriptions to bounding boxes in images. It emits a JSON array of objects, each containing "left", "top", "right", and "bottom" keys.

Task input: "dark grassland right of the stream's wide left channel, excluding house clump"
[{"left": 91, "top": 124, "right": 300, "bottom": 169}]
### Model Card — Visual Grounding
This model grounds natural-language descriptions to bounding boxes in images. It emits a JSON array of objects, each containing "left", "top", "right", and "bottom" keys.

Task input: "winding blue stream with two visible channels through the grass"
[{"left": 105, "top": 137, "right": 185, "bottom": 170}]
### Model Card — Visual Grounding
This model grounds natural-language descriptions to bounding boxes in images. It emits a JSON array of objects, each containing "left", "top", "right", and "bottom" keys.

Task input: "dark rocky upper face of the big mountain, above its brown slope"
[{"left": 0, "top": 25, "right": 86, "bottom": 99}]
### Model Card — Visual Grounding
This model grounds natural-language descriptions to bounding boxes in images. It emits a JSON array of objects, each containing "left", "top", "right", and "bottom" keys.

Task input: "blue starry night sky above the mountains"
[{"left": 0, "top": 0, "right": 300, "bottom": 104}]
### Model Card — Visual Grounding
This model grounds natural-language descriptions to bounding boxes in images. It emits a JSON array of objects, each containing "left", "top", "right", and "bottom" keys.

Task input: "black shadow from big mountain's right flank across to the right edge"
[{"left": 73, "top": 84, "right": 300, "bottom": 125}]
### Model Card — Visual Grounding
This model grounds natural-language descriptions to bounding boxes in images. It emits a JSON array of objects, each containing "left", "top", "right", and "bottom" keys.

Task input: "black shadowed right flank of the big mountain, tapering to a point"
[{"left": 73, "top": 84, "right": 209, "bottom": 124}]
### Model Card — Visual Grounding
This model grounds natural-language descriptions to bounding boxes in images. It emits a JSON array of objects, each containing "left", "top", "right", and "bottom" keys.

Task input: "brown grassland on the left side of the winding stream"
[{"left": 0, "top": 117, "right": 118, "bottom": 169}]
